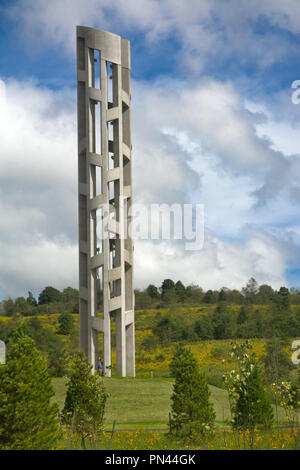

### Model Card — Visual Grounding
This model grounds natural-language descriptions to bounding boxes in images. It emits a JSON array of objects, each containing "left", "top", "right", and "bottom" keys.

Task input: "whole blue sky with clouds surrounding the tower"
[{"left": 0, "top": 0, "right": 300, "bottom": 299}]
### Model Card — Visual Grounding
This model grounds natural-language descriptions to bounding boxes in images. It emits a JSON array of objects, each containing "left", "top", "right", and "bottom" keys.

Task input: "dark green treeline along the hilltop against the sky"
[{"left": 0, "top": 278, "right": 300, "bottom": 316}]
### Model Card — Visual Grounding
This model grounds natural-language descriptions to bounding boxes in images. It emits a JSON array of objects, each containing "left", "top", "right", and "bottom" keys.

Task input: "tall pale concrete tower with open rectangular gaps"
[{"left": 77, "top": 26, "right": 135, "bottom": 376}]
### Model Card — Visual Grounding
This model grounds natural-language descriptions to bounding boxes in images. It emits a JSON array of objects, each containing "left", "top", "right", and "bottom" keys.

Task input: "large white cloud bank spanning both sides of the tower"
[{"left": 0, "top": 73, "right": 298, "bottom": 296}]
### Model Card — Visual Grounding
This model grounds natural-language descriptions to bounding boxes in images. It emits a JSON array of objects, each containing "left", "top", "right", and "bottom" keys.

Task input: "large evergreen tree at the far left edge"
[{"left": 0, "top": 326, "right": 61, "bottom": 450}]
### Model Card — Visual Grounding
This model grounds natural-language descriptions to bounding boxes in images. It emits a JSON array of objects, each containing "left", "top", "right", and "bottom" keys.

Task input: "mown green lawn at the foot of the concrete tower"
[{"left": 53, "top": 377, "right": 296, "bottom": 429}]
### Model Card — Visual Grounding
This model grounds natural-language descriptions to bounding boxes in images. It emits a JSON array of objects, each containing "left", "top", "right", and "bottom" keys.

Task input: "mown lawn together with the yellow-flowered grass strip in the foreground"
[{"left": 53, "top": 378, "right": 300, "bottom": 450}]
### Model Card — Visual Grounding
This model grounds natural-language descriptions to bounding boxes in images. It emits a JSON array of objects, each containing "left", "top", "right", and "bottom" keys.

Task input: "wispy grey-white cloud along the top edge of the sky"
[{"left": 2, "top": 0, "right": 300, "bottom": 73}]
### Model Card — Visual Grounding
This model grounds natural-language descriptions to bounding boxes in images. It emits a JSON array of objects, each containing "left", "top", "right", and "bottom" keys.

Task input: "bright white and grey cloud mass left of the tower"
[{"left": 0, "top": 81, "right": 77, "bottom": 296}]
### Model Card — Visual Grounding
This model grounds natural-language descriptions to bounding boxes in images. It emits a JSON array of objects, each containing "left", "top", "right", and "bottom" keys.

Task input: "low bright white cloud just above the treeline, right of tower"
[{"left": 135, "top": 228, "right": 292, "bottom": 289}]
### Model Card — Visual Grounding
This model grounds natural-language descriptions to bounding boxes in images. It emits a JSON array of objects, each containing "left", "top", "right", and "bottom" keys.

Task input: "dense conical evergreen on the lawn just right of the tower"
[{"left": 171, "top": 346, "right": 215, "bottom": 438}]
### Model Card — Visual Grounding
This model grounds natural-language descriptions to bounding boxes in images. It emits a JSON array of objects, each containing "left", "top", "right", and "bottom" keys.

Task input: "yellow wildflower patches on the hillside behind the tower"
[{"left": 0, "top": 305, "right": 291, "bottom": 380}]
